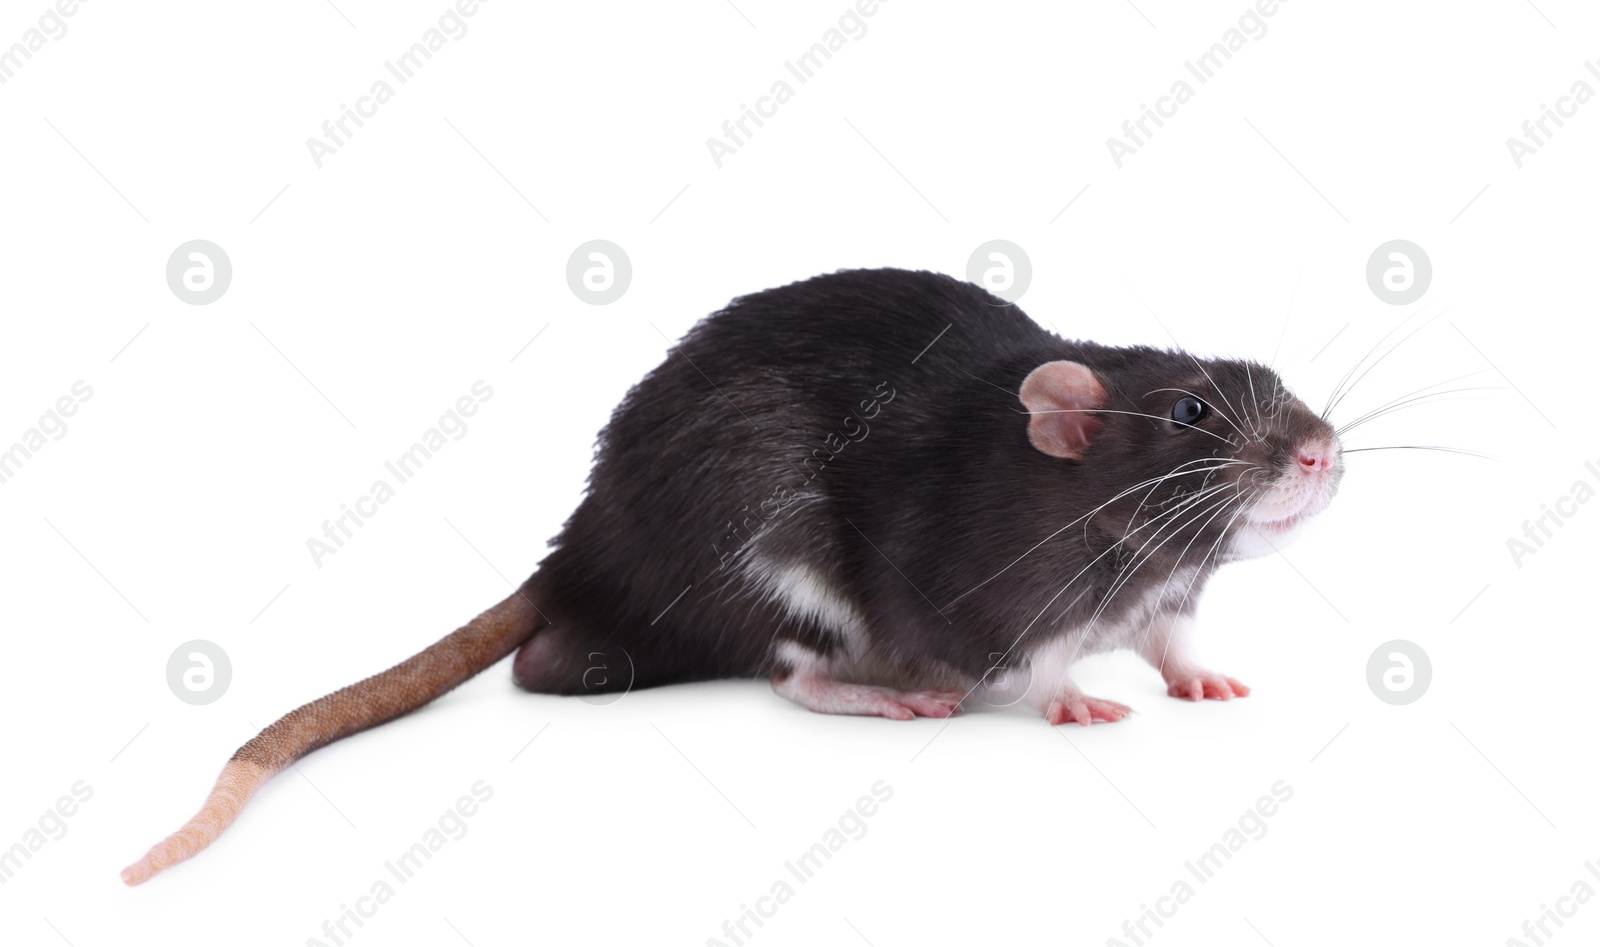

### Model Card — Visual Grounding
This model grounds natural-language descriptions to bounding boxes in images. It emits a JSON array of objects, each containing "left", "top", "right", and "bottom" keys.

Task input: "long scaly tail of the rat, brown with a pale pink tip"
[{"left": 122, "top": 585, "right": 544, "bottom": 885}]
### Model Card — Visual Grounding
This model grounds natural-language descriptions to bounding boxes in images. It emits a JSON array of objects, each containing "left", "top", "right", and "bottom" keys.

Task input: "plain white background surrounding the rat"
[{"left": 0, "top": 0, "right": 1600, "bottom": 947}]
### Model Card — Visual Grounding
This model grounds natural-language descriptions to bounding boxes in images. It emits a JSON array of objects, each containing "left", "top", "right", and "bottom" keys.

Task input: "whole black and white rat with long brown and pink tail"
[{"left": 122, "top": 269, "right": 1344, "bottom": 885}]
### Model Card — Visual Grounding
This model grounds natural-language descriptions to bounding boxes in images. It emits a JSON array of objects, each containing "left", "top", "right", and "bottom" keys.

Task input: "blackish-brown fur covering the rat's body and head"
[{"left": 515, "top": 270, "right": 1326, "bottom": 693}]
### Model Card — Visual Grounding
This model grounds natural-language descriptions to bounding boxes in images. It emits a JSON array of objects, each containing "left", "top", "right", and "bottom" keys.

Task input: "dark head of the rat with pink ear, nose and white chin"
[{"left": 1018, "top": 347, "right": 1344, "bottom": 560}]
